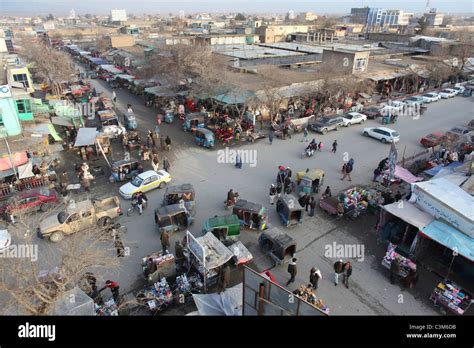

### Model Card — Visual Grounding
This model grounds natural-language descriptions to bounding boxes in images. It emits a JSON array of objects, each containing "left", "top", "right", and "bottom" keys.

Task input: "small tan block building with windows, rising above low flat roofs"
[{"left": 322, "top": 49, "right": 370, "bottom": 74}]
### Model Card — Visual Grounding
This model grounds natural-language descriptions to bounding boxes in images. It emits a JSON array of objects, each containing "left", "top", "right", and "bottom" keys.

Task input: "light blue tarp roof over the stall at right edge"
[{"left": 421, "top": 220, "right": 474, "bottom": 261}]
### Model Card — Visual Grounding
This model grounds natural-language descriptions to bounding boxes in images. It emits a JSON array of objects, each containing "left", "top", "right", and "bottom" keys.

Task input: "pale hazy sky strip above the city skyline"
[{"left": 0, "top": 0, "right": 474, "bottom": 16}]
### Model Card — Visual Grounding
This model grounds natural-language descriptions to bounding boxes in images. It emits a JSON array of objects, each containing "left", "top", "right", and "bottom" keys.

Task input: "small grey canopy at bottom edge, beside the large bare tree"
[{"left": 54, "top": 286, "right": 95, "bottom": 315}]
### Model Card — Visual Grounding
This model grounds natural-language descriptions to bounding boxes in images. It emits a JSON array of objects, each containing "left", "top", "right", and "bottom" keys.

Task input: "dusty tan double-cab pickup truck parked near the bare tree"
[{"left": 37, "top": 196, "right": 122, "bottom": 243}]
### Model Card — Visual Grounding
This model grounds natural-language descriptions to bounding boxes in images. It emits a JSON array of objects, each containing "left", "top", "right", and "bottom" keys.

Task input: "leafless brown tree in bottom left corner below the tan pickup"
[{"left": 0, "top": 206, "right": 118, "bottom": 315}]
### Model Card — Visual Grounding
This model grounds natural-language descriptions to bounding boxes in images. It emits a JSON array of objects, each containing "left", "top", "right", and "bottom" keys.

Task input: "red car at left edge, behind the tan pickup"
[{"left": 0, "top": 188, "right": 59, "bottom": 219}]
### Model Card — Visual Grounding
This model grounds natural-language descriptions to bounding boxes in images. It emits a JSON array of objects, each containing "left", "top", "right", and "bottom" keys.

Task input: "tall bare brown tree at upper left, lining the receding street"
[{"left": 19, "top": 39, "right": 75, "bottom": 94}]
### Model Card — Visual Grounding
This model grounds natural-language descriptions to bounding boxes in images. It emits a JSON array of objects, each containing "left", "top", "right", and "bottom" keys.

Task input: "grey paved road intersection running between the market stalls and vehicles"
[{"left": 47, "top": 66, "right": 474, "bottom": 315}]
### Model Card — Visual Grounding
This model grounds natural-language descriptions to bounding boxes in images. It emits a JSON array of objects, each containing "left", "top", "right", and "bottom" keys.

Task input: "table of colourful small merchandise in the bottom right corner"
[{"left": 430, "top": 280, "right": 472, "bottom": 315}]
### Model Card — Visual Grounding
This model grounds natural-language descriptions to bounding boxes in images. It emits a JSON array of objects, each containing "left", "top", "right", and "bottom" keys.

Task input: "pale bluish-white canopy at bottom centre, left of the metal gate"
[{"left": 193, "top": 283, "right": 243, "bottom": 316}]
